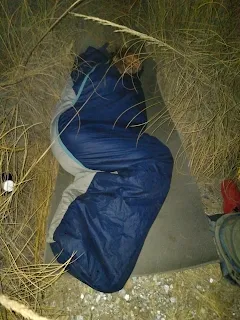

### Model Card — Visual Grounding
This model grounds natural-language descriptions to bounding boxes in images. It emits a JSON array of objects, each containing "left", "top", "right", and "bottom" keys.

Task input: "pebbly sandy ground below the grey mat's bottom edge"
[{"left": 44, "top": 264, "right": 240, "bottom": 320}]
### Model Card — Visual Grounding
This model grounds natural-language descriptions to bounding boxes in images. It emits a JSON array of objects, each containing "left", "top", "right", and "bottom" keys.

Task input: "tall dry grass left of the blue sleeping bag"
[{"left": 0, "top": 1, "right": 78, "bottom": 319}]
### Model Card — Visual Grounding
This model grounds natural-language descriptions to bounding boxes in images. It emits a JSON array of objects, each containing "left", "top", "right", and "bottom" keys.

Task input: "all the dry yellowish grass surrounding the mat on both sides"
[{"left": 0, "top": 0, "right": 240, "bottom": 319}]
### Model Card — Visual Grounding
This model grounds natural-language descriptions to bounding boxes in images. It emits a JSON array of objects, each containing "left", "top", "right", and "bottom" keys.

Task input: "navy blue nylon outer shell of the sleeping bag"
[{"left": 51, "top": 47, "right": 173, "bottom": 292}]
